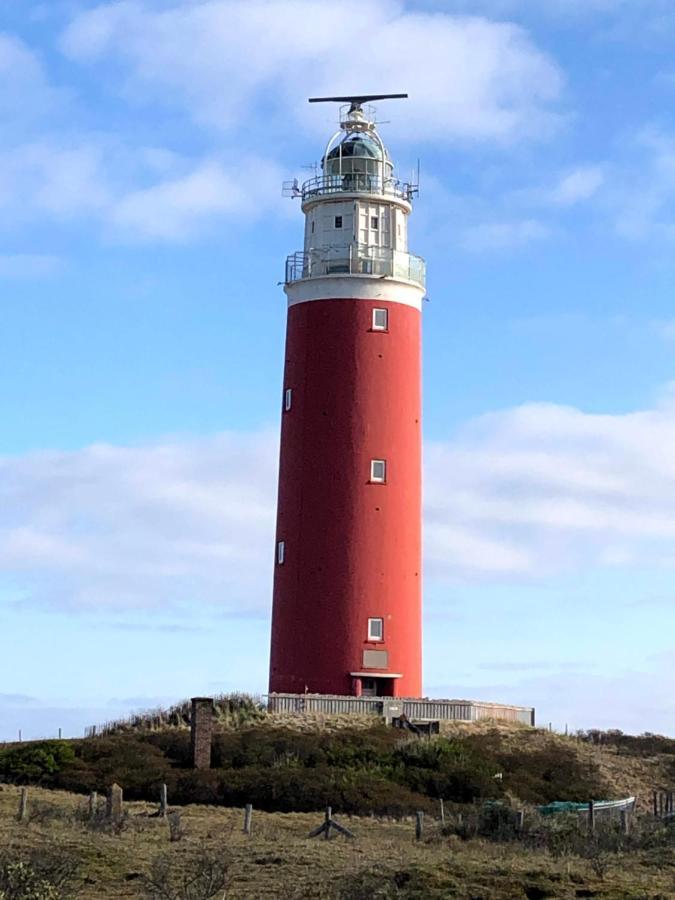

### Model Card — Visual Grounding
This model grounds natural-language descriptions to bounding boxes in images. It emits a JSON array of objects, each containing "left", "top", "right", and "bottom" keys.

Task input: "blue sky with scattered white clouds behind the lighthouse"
[{"left": 0, "top": 0, "right": 675, "bottom": 738}]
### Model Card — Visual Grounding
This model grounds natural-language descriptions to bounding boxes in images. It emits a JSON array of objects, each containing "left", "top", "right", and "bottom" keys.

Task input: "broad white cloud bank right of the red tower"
[{"left": 426, "top": 397, "right": 675, "bottom": 576}]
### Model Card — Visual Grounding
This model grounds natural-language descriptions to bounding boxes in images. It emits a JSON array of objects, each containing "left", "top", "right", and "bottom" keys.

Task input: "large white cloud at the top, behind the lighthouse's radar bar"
[{"left": 62, "top": 0, "right": 562, "bottom": 142}]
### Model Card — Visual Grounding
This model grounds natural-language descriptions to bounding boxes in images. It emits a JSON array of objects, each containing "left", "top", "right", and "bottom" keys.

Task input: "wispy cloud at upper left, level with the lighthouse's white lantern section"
[{"left": 0, "top": 137, "right": 282, "bottom": 239}]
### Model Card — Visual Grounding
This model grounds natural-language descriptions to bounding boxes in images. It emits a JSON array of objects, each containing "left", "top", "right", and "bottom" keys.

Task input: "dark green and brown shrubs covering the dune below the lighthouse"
[{"left": 0, "top": 723, "right": 611, "bottom": 815}]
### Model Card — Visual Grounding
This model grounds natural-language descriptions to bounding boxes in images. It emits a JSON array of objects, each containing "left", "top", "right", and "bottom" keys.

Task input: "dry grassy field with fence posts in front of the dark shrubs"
[{"left": 0, "top": 786, "right": 675, "bottom": 900}]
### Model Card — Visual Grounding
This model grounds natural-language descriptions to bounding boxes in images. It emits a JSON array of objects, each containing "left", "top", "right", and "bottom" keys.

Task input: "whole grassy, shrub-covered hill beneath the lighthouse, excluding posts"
[{"left": 0, "top": 709, "right": 675, "bottom": 900}]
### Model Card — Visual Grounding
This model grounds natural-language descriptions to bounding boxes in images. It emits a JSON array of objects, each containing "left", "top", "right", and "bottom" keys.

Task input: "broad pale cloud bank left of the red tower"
[{"left": 0, "top": 435, "right": 276, "bottom": 612}]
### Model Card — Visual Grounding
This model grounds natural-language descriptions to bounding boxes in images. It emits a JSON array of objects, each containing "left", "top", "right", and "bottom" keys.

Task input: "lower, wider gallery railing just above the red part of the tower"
[{"left": 286, "top": 244, "right": 426, "bottom": 288}]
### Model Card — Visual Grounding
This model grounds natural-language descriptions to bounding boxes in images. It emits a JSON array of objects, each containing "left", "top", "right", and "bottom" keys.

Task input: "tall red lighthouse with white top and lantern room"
[{"left": 270, "top": 95, "right": 424, "bottom": 697}]
